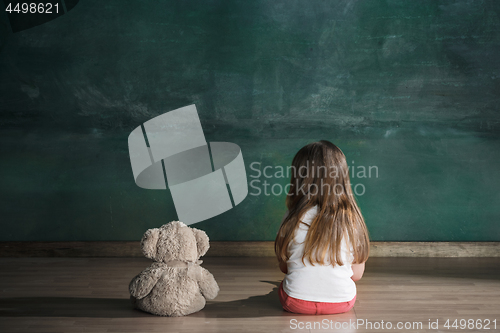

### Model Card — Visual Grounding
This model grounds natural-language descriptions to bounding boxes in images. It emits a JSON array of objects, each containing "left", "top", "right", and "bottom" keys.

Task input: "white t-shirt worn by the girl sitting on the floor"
[{"left": 283, "top": 206, "right": 356, "bottom": 303}]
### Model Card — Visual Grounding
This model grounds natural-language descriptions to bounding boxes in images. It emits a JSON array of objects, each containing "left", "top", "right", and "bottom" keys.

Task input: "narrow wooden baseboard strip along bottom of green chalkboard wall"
[{"left": 0, "top": 241, "right": 500, "bottom": 257}]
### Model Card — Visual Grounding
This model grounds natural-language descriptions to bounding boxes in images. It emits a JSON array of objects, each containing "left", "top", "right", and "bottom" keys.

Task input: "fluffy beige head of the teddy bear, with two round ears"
[{"left": 141, "top": 221, "right": 210, "bottom": 262}]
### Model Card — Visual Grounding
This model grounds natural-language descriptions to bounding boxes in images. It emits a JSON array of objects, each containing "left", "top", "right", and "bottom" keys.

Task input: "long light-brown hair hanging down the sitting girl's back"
[{"left": 274, "top": 140, "right": 370, "bottom": 266}]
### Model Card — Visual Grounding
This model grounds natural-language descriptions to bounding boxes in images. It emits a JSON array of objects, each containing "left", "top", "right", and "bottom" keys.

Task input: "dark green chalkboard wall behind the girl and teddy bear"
[{"left": 0, "top": 0, "right": 500, "bottom": 241}]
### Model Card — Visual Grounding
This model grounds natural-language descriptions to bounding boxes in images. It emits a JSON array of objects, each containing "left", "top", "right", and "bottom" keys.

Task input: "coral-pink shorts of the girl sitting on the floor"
[{"left": 279, "top": 281, "right": 356, "bottom": 314}]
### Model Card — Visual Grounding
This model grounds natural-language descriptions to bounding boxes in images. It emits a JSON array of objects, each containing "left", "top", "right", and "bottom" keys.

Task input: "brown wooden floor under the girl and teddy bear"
[{"left": 0, "top": 257, "right": 500, "bottom": 333}]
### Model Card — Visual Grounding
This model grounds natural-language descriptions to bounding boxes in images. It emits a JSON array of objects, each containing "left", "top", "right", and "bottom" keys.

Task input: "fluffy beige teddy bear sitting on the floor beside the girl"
[{"left": 129, "top": 221, "right": 219, "bottom": 317}]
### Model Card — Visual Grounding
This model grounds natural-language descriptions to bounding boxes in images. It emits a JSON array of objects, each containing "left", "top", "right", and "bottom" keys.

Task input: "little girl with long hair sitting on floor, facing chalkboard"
[{"left": 274, "top": 141, "right": 370, "bottom": 314}]
